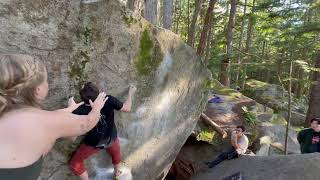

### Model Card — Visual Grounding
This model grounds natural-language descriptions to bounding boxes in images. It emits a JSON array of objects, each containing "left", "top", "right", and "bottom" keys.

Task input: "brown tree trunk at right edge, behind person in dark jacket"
[{"left": 305, "top": 51, "right": 320, "bottom": 127}]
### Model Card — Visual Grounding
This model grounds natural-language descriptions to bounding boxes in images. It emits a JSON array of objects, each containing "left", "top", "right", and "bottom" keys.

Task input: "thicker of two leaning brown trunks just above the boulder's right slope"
[{"left": 197, "top": 0, "right": 218, "bottom": 57}]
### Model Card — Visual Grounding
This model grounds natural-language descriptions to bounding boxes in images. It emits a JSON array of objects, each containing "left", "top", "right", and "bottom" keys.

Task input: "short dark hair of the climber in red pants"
[{"left": 79, "top": 82, "right": 99, "bottom": 104}]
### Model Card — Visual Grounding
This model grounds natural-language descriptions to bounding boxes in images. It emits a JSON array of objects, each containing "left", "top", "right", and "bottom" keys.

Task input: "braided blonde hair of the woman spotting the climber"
[{"left": 0, "top": 54, "right": 46, "bottom": 116}]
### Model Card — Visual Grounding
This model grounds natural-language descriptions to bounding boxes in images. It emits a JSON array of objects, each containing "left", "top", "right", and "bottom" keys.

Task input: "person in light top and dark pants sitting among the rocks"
[{"left": 206, "top": 126, "right": 249, "bottom": 168}]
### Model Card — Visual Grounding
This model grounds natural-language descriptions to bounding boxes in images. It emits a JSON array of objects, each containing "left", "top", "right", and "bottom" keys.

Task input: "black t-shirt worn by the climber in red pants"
[{"left": 72, "top": 95, "right": 123, "bottom": 148}]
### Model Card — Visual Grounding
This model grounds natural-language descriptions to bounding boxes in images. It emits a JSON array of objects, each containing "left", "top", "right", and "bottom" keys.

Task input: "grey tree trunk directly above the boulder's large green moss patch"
[{"left": 144, "top": 0, "right": 158, "bottom": 25}]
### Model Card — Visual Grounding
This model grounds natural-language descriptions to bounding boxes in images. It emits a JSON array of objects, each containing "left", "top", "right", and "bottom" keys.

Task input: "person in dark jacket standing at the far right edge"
[{"left": 297, "top": 118, "right": 320, "bottom": 154}]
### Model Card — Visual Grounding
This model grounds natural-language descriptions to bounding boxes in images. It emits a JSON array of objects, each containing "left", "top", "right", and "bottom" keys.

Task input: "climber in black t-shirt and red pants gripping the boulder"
[{"left": 69, "top": 82, "right": 136, "bottom": 180}]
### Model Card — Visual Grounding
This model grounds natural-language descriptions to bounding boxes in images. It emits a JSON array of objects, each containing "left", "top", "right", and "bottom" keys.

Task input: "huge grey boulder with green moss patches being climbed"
[{"left": 0, "top": 0, "right": 207, "bottom": 180}]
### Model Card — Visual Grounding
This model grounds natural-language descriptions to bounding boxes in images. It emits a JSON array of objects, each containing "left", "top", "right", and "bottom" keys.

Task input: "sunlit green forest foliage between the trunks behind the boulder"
[{"left": 172, "top": 0, "right": 320, "bottom": 96}]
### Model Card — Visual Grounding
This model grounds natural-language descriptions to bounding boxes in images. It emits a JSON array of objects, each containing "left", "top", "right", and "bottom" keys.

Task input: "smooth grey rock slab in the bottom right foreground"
[{"left": 191, "top": 153, "right": 320, "bottom": 180}]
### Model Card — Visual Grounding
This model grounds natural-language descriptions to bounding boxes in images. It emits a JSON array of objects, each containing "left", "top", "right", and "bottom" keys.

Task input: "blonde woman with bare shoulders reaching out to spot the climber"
[{"left": 0, "top": 54, "right": 107, "bottom": 180}]
